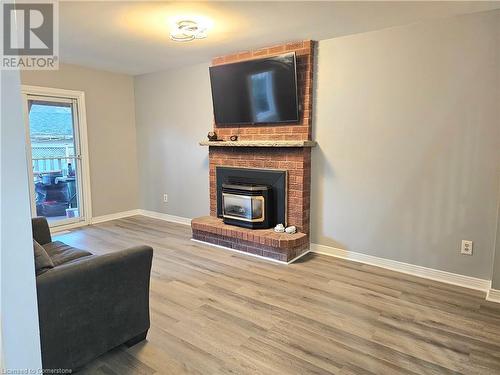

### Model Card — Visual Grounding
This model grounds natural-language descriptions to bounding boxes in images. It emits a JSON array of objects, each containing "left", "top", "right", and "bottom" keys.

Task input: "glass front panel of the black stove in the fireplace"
[{"left": 222, "top": 193, "right": 265, "bottom": 222}]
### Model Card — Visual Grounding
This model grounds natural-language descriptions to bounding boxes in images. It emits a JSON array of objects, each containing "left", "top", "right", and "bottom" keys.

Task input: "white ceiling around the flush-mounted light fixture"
[{"left": 59, "top": 1, "right": 500, "bottom": 75}]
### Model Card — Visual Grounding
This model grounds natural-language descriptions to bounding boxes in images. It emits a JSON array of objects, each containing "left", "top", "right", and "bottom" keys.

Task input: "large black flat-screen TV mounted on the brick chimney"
[{"left": 210, "top": 53, "right": 299, "bottom": 125}]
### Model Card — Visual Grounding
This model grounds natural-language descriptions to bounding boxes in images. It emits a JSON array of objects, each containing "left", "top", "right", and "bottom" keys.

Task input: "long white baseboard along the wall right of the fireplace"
[{"left": 311, "top": 243, "right": 491, "bottom": 292}]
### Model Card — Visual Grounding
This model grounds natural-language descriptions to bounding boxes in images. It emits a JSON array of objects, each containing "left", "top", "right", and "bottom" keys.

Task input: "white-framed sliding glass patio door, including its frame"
[{"left": 24, "top": 92, "right": 89, "bottom": 227}]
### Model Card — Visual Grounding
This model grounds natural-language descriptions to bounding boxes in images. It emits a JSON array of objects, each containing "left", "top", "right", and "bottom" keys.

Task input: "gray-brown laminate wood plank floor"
[{"left": 56, "top": 216, "right": 500, "bottom": 375}]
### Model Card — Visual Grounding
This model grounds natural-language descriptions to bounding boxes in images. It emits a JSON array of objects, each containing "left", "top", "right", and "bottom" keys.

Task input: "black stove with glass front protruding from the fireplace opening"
[{"left": 222, "top": 184, "right": 273, "bottom": 229}]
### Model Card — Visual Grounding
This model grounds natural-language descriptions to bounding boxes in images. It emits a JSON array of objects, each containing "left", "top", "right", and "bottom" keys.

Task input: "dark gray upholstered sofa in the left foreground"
[{"left": 32, "top": 218, "right": 153, "bottom": 370}]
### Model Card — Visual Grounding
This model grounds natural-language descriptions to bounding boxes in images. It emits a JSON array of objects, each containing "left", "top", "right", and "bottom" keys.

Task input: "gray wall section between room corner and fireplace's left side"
[{"left": 135, "top": 64, "right": 212, "bottom": 217}]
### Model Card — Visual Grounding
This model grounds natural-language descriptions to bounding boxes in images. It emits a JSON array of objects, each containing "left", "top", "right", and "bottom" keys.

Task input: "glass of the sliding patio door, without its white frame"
[{"left": 29, "top": 101, "right": 80, "bottom": 224}]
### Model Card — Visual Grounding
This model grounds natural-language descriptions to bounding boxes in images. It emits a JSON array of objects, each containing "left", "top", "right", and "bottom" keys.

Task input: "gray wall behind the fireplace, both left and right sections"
[{"left": 135, "top": 11, "right": 500, "bottom": 279}]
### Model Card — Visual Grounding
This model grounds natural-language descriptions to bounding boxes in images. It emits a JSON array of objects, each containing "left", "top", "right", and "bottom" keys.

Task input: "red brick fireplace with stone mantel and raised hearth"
[{"left": 191, "top": 41, "right": 315, "bottom": 262}]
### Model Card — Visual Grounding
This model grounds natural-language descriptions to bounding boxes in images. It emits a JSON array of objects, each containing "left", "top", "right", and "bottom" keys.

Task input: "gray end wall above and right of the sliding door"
[{"left": 21, "top": 64, "right": 139, "bottom": 217}]
